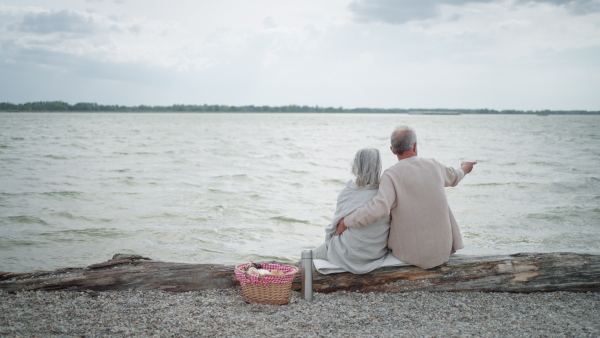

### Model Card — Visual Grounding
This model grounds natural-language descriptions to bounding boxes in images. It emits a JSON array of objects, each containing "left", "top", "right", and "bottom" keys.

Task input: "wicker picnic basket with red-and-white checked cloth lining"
[{"left": 235, "top": 264, "right": 298, "bottom": 305}]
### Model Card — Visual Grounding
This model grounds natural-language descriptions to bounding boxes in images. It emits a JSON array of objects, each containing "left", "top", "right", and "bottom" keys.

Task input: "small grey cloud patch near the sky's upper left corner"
[{"left": 18, "top": 10, "right": 94, "bottom": 34}]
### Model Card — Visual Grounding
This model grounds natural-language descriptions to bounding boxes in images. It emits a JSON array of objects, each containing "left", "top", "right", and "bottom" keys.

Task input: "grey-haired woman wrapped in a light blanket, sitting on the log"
[{"left": 313, "top": 148, "right": 390, "bottom": 274}]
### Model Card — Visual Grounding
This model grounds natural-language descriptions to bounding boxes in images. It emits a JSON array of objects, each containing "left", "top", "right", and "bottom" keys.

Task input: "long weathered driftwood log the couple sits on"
[{"left": 0, "top": 253, "right": 600, "bottom": 293}]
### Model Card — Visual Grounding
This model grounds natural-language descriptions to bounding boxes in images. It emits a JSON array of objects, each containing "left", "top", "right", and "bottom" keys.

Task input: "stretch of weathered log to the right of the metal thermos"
[{"left": 313, "top": 253, "right": 600, "bottom": 292}]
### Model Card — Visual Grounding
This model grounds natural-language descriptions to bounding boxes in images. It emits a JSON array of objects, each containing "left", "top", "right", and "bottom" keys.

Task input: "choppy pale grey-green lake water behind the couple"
[{"left": 0, "top": 113, "right": 600, "bottom": 271}]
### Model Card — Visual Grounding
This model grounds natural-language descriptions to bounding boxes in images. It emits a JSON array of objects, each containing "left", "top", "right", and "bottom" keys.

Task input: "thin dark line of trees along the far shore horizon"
[{"left": 0, "top": 101, "right": 600, "bottom": 115}]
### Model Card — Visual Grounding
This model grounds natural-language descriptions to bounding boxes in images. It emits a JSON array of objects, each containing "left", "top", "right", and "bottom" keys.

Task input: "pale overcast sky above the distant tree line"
[{"left": 0, "top": 0, "right": 600, "bottom": 111}]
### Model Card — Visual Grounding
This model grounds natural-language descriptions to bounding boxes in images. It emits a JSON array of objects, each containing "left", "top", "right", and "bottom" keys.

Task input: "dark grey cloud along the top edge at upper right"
[{"left": 348, "top": 0, "right": 600, "bottom": 24}]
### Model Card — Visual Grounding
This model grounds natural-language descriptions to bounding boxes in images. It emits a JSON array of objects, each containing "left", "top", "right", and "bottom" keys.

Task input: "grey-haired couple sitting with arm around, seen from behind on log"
[{"left": 313, "top": 126, "right": 477, "bottom": 274}]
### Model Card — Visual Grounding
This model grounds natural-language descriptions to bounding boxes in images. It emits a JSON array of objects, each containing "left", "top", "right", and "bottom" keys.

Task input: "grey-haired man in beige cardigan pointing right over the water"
[{"left": 337, "top": 126, "right": 477, "bottom": 269}]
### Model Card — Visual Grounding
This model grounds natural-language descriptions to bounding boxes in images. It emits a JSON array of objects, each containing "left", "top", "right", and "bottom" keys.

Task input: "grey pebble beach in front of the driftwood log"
[{"left": 0, "top": 289, "right": 600, "bottom": 337}]
